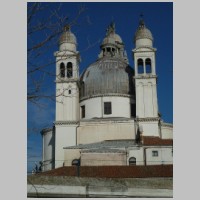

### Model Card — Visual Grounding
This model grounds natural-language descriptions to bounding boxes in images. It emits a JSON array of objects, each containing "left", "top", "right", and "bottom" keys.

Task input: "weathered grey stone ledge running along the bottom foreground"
[{"left": 27, "top": 176, "right": 173, "bottom": 197}]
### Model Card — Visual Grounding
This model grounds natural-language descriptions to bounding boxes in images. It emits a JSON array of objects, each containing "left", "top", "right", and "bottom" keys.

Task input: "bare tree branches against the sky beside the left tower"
[{"left": 27, "top": 2, "right": 85, "bottom": 105}]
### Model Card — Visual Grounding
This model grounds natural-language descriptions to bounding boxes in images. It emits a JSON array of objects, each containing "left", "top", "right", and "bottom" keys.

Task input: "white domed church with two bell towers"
[{"left": 41, "top": 19, "right": 173, "bottom": 171}]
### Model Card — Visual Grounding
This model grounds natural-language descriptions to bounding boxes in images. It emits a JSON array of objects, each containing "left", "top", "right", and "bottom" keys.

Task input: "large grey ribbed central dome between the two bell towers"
[{"left": 80, "top": 57, "right": 134, "bottom": 98}]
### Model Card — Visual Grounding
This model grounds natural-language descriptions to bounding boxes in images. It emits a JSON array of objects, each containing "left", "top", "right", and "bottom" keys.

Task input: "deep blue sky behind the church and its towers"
[{"left": 27, "top": 2, "right": 173, "bottom": 173}]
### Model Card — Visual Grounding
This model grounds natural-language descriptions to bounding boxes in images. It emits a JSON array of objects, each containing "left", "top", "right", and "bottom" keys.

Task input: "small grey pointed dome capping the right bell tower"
[{"left": 134, "top": 20, "right": 153, "bottom": 41}]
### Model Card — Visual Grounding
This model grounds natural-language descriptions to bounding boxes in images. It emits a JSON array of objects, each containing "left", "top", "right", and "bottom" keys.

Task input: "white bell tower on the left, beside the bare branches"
[{"left": 54, "top": 26, "right": 80, "bottom": 168}]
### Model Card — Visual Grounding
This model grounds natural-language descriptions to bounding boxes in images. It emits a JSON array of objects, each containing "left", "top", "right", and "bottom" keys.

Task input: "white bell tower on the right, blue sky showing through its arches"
[{"left": 132, "top": 18, "right": 159, "bottom": 136}]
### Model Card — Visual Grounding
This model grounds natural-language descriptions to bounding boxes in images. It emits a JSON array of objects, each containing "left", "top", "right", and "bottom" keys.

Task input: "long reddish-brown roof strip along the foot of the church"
[{"left": 38, "top": 165, "right": 173, "bottom": 178}]
